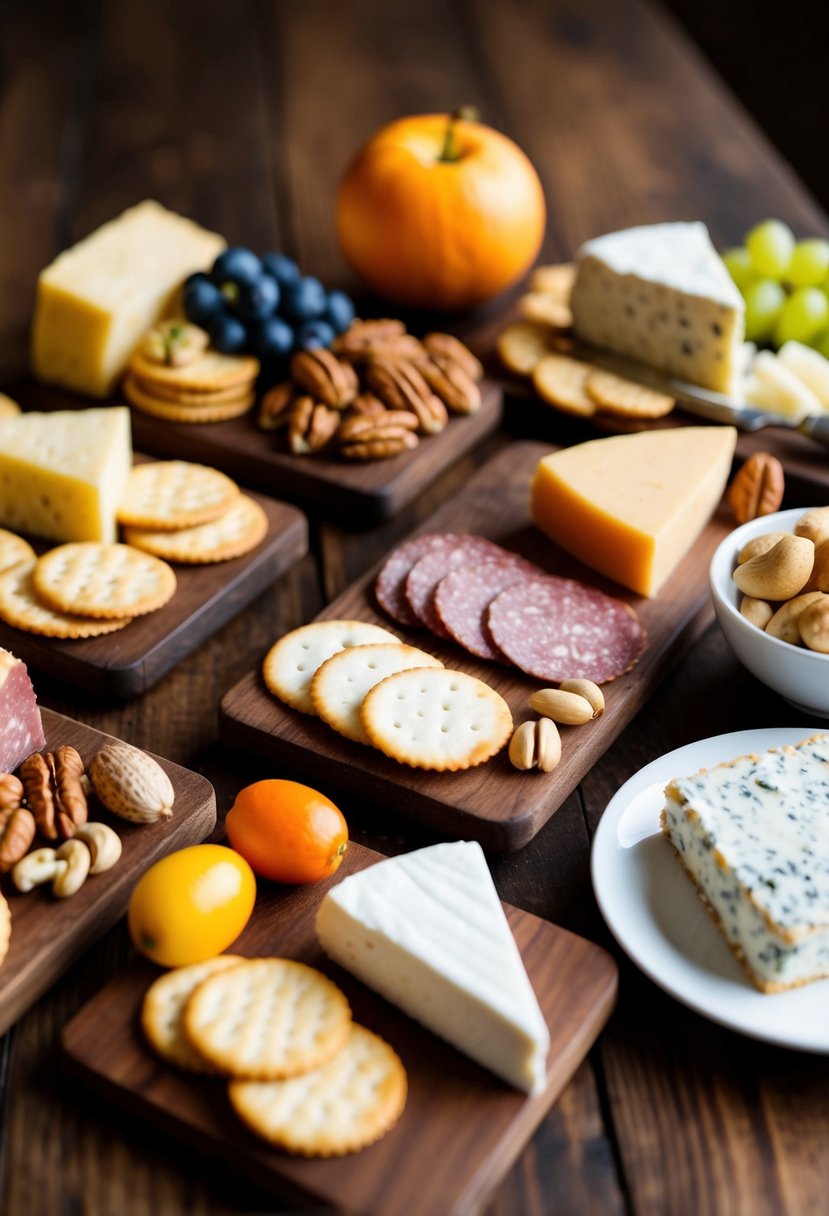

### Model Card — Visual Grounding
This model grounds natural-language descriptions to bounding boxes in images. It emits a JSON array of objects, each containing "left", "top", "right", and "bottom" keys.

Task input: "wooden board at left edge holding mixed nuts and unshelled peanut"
[{"left": 0, "top": 709, "right": 216, "bottom": 1034}]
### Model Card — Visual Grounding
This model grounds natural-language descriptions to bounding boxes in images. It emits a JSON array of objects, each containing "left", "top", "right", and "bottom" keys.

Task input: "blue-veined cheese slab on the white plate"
[{"left": 661, "top": 734, "right": 829, "bottom": 992}]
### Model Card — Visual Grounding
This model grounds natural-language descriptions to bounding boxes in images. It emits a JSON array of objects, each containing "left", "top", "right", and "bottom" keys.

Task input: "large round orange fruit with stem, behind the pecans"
[{"left": 337, "top": 114, "right": 546, "bottom": 310}]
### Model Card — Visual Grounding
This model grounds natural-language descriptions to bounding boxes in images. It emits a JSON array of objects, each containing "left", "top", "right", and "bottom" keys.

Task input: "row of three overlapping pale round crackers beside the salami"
[{"left": 263, "top": 620, "right": 513, "bottom": 772}]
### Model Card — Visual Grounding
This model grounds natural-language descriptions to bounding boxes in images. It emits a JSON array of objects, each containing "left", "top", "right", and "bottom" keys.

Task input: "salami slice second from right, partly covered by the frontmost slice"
[{"left": 434, "top": 558, "right": 543, "bottom": 663}]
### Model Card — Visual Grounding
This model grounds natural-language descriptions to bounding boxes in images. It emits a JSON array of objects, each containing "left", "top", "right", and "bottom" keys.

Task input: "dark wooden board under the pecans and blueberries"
[{"left": 131, "top": 383, "right": 502, "bottom": 523}]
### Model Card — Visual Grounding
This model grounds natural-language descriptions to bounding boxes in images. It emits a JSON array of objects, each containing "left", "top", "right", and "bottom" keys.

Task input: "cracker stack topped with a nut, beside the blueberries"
[{"left": 123, "top": 320, "right": 259, "bottom": 423}]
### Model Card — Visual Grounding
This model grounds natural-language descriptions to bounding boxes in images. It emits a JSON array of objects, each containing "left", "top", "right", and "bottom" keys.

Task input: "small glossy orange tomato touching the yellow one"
[{"left": 225, "top": 779, "right": 349, "bottom": 883}]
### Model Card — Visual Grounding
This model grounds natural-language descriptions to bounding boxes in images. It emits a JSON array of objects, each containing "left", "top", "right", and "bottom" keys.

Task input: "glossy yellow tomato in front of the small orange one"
[{"left": 126, "top": 844, "right": 256, "bottom": 967}]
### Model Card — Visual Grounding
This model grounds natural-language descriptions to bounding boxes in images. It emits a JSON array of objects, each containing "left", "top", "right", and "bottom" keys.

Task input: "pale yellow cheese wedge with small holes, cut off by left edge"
[{"left": 0, "top": 405, "right": 132, "bottom": 541}]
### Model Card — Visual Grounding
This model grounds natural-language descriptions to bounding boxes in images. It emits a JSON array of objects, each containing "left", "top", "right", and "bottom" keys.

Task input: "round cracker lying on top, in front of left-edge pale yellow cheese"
[{"left": 32, "top": 541, "right": 176, "bottom": 619}]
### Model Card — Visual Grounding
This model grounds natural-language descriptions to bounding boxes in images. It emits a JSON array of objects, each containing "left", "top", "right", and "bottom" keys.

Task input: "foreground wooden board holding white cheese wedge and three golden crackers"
[{"left": 63, "top": 843, "right": 616, "bottom": 1216}]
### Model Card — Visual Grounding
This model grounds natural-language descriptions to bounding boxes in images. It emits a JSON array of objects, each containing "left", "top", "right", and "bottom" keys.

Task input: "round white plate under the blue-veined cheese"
[{"left": 591, "top": 726, "right": 829, "bottom": 1053}]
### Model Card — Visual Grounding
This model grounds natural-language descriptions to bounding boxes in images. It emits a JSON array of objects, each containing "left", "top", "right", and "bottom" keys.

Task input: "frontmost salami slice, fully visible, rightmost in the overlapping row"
[{"left": 486, "top": 576, "right": 648, "bottom": 683}]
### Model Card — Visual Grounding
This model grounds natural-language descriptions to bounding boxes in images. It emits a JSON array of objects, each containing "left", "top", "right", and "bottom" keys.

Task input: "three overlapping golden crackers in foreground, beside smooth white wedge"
[{"left": 141, "top": 955, "right": 407, "bottom": 1156}]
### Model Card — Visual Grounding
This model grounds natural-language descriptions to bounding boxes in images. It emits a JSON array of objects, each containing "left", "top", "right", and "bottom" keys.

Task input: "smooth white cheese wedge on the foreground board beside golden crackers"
[{"left": 316, "top": 840, "right": 549, "bottom": 1093}]
